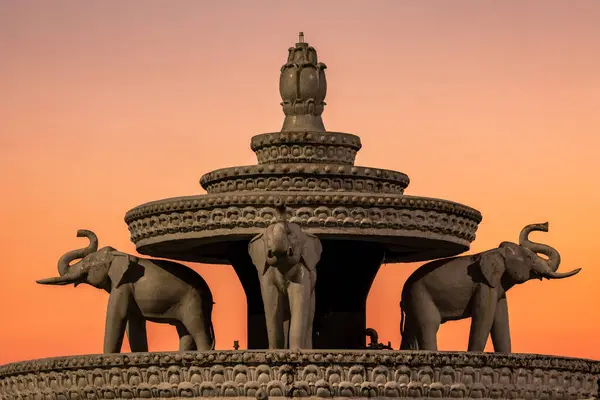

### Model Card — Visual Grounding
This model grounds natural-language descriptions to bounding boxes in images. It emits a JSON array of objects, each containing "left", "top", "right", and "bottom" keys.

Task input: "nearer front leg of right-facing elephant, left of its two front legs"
[{"left": 468, "top": 285, "right": 498, "bottom": 351}]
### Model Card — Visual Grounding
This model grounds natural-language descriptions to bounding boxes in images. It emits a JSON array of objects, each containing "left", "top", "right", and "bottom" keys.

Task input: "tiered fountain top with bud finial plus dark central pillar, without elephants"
[{"left": 125, "top": 31, "right": 481, "bottom": 349}]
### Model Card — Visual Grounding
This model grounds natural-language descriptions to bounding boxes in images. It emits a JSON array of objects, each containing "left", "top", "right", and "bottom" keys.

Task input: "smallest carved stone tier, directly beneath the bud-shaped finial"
[{"left": 250, "top": 132, "right": 362, "bottom": 165}]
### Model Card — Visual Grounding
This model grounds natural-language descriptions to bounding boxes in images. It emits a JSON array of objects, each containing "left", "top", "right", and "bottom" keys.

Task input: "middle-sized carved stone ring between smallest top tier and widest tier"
[{"left": 200, "top": 164, "right": 410, "bottom": 194}]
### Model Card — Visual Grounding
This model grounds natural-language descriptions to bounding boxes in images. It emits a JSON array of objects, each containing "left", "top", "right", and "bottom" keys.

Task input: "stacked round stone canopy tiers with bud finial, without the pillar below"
[{"left": 125, "top": 37, "right": 482, "bottom": 264}]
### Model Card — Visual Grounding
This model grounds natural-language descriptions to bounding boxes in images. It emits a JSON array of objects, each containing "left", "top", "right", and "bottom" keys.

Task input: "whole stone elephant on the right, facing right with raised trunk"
[{"left": 400, "top": 222, "right": 581, "bottom": 353}]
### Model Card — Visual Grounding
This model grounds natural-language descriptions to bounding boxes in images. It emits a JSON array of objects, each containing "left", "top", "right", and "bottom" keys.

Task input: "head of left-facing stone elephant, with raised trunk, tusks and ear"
[{"left": 36, "top": 230, "right": 139, "bottom": 291}]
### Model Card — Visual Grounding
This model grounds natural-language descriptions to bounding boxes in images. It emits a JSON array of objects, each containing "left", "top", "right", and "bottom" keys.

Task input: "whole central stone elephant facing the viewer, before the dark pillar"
[{"left": 248, "top": 200, "right": 322, "bottom": 349}]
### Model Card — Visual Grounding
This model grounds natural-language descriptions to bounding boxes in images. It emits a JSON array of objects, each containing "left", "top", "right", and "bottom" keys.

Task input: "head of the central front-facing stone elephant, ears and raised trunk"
[{"left": 249, "top": 200, "right": 322, "bottom": 273}]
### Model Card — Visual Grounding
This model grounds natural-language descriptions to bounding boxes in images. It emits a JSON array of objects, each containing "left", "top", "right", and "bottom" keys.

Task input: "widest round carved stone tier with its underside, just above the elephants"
[{"left": 125, "top": 191, "right": 481, "bottom": 263}]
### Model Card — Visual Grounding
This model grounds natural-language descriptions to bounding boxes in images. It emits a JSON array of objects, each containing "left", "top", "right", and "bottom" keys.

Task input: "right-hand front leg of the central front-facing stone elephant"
[{"left": 288, "top": 276, "right": 312, "bottom": 350}]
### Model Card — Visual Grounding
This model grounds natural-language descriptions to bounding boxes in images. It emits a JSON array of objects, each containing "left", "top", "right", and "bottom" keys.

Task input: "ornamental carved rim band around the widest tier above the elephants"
[{"left": 126, "top": 194, "right": 481, "bottom": 243}]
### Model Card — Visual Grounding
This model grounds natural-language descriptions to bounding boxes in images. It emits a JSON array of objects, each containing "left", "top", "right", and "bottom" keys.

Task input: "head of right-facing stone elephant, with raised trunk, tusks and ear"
[{"left": 478, "top": 222, "right": 581, "bottom": 287}]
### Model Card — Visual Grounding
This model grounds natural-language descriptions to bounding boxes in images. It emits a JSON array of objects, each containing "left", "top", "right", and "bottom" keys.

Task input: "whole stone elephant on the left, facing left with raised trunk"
[{"left": 37, "top": 230, "right": 215, "bottom": 353}]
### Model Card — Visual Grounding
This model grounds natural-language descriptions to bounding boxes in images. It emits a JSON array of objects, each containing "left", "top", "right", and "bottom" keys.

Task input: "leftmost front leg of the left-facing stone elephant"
[{"left": 104, "top": 286, "right": 131, "bottom": 353}]
